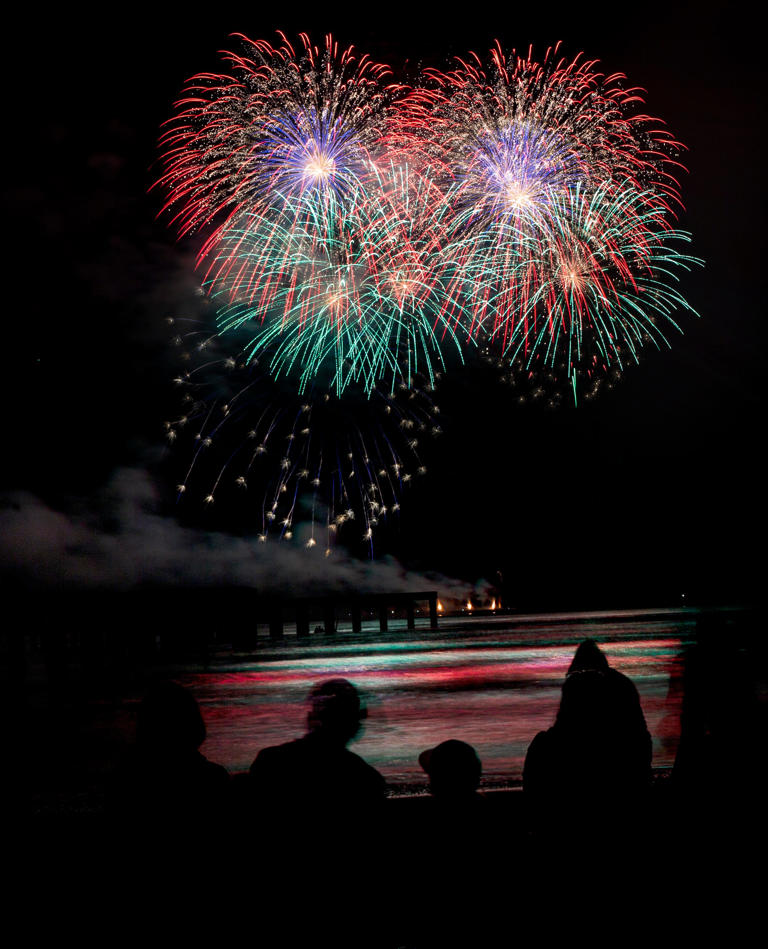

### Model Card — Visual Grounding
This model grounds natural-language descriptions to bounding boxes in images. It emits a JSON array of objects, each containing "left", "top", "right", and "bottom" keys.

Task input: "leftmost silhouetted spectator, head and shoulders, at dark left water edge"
[{"left": 113, "top": 682, "right": 230, "bottom": 832}]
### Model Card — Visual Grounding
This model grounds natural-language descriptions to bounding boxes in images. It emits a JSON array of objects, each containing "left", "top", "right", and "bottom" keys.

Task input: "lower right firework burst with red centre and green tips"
[{"left": 504, "top": 182, "right": 699, "bottom": 385}]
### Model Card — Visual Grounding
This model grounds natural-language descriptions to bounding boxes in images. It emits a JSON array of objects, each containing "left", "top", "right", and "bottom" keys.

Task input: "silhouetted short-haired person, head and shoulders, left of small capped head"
[{"left": 250, "top": 679, "right": 386, "bottom": 817}]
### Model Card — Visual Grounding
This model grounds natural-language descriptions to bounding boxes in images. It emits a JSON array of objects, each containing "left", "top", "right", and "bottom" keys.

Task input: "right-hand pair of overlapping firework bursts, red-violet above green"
[{"left": 398, "top": 44, "right": 700, "bottom": 386}]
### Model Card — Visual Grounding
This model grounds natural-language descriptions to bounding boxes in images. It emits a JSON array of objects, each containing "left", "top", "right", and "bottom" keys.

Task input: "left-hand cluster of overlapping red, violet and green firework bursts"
[{"left": 158, "top": 29, "right": 468, "bottom": 394}]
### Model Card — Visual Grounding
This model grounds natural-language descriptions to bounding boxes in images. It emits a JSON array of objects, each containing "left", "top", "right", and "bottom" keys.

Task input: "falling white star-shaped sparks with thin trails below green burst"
[{"left": 166, "top": 322, "right": 441, "bottom": 550}]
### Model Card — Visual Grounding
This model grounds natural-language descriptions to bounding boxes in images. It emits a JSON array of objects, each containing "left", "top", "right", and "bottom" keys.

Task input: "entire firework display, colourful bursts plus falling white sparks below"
[{"left": 156, "top": 34, "right": 700, "bottom": 546}]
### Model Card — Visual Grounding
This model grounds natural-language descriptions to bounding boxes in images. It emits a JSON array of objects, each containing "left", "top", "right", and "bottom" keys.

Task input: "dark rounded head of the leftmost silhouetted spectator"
[{"left": 136, "top": 682, "right": 205, "bottom": 753}]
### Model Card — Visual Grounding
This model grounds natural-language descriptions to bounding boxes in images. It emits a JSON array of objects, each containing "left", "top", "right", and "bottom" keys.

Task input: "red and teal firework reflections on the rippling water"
[{"left": 182, "top": 611, "right": 696, "bottom": 787}]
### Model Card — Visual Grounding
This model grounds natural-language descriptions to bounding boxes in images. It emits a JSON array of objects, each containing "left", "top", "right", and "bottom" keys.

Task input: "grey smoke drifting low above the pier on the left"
[{"left": 0, "top": 468, "right": 472, "bottom": 600}]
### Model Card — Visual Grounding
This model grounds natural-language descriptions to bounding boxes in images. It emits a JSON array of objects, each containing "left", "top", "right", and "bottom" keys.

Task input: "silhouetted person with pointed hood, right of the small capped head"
[{"left": 523, "top": 640, "right": 651, "bottom": 836}]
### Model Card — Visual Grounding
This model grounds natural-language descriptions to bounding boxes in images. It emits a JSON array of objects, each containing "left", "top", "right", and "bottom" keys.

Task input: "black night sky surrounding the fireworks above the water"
[{"left": 0, "top": 3, "right": 765, "bottom": 607}]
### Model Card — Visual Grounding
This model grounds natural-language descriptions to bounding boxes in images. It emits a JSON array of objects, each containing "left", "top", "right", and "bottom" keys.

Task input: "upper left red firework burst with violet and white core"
[{"left": 157, "top": 34, "right": 397, "bottom": 239}]
